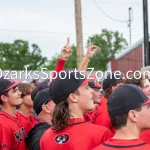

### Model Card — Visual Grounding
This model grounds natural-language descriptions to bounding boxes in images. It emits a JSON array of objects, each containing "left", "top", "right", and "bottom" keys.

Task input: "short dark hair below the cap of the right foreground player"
[{"left": 110, "top": 107, "right": 141, "bottom": 130}]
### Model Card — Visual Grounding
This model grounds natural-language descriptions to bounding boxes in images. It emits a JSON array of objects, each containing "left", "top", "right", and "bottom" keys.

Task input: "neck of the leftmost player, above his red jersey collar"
[{"left": 1, "top": 105, "right": 16, "bottom": 117}]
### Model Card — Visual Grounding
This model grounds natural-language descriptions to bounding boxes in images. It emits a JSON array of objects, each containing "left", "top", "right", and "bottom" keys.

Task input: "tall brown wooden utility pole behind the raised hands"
[{"left": 74, "top": 0, "right": 84, "bottom": 68}]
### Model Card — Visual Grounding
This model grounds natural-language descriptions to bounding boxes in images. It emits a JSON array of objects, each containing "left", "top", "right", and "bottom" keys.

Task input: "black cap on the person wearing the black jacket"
[{"left": 33, "top": 88, "right": 51, "bottom": 115}]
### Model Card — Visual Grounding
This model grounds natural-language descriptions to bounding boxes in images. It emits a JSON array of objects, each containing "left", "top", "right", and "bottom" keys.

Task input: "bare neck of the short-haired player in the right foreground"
[{"left": 113, "top": 126, "right": 140, "bottom": 139}]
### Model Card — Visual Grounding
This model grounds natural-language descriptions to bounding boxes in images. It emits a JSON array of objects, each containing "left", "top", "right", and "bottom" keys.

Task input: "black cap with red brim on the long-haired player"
[{"left": 49, "top": 71, "right": 95, "bottom": 104}]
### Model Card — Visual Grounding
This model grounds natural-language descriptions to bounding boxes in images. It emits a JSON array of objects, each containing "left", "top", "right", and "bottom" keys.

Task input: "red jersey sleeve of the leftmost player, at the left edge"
[{"left": 0, "top": 124, "right": 13, "bottom": 150}]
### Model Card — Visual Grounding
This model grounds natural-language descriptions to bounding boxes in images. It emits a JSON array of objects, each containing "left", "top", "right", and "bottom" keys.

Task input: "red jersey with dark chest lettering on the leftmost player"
[{"left": 0, "top": 111, "right": 25, "bottom": 150}]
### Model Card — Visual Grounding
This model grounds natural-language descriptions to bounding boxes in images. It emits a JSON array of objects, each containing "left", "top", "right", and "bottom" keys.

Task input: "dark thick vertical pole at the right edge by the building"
[{"left": 143, "top": 0, "right": 150, "bottom": 66}]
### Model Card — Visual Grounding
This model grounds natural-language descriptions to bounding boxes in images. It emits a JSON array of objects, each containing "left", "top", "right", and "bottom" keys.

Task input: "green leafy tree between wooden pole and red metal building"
[{"left": 88, "top": 29, "right": 128, "bottom": 71}]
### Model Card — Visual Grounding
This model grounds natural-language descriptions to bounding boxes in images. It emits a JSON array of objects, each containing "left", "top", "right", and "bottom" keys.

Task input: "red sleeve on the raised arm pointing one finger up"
[{"left": 52, "top": 58, "right": 66, "bottom": 78}]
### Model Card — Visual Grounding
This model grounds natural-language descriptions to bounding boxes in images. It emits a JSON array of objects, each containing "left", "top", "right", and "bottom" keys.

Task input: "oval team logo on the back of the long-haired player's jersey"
[{"left": 55, "top": 134, "right": 70, "bottom": 144}]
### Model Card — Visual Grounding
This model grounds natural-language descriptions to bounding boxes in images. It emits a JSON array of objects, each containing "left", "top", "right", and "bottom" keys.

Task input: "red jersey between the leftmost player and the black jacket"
[{"left": 16, "top": 112, "right": 38, "bottom": 135}]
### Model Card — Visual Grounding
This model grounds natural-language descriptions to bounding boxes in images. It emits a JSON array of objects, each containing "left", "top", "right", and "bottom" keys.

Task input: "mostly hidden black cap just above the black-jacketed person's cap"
[{"left": 31, "top": 79, "right": 50, "bottom": 100}]
